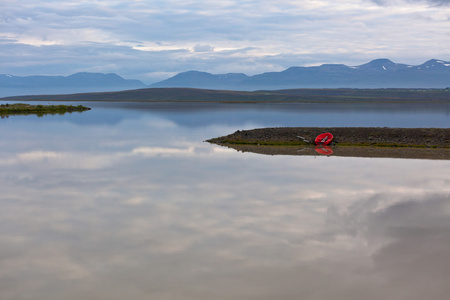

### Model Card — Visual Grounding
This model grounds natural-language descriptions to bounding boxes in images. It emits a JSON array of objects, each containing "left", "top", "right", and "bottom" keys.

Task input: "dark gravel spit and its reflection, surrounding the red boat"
[{"left": 207, "top": 127, "right": 450, "bottom": 160}]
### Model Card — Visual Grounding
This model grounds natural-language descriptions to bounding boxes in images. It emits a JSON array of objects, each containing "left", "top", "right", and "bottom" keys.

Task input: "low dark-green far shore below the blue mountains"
[{"left": 0, "top": 88, "right": 450, "bottom": 104}]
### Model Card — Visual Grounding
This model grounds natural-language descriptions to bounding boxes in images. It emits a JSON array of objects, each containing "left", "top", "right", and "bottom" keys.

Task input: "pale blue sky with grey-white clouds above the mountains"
[{"left": 0, "top": 0, "right": 450, "bottom": 84}]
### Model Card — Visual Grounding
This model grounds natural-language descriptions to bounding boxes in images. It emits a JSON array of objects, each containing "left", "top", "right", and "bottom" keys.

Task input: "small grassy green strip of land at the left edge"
[{"left": 0, "top": 103, "right": 90, "bottom": 118}]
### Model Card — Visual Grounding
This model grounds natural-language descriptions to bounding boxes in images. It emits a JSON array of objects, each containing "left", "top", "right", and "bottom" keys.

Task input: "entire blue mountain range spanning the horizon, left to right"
[{"left": 0, "top": 59, "right": 450, "bottom": 97}]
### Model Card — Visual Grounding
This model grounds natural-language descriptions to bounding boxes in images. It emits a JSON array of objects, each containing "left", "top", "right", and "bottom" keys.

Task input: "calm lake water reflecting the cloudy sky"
[{"left": 0, "top": 102, "right": 450, "bottom": 300}]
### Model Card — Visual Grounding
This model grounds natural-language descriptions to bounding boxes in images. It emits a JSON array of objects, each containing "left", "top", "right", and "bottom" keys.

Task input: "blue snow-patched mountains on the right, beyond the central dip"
[{"left": 151, "top": 59, "right": 450, "bottom": 90}]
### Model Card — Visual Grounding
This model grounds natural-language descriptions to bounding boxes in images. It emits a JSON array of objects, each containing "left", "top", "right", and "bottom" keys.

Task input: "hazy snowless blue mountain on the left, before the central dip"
[{"left": 0, "top": 72, "right": 146, "bottom": 97}]
